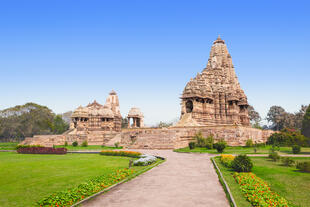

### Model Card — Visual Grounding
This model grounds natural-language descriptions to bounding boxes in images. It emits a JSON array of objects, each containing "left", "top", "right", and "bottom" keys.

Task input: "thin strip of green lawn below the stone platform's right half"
[{"left": 174, "top": 145, "right": 310, "bottom": 154}]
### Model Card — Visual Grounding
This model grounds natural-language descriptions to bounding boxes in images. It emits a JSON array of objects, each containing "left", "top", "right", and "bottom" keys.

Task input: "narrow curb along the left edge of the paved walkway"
[{"left": 70, "top": 156, "right": 166, "bottom": 207}]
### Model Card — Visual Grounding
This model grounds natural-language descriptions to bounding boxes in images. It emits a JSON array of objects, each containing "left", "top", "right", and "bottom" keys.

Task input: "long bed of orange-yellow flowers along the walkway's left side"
[{"left": 37, "top": 169, "right": 134, "bottom": 207}]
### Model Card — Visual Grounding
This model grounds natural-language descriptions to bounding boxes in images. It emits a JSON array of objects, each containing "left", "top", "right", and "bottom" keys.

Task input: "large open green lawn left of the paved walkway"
[{"left": 0, "top": 152, "right": 151, "bottom": 207}]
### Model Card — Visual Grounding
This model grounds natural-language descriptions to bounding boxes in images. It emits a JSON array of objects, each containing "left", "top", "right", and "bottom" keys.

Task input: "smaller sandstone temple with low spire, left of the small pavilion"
[{"left": 70, "top": 91, "right": 122, "bottom": 132}]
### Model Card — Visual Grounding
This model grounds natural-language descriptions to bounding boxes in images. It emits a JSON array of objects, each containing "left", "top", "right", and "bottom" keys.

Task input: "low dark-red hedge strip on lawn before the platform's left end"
[{"left": 17, "top": 146, "right": 67, "bottom": 155}]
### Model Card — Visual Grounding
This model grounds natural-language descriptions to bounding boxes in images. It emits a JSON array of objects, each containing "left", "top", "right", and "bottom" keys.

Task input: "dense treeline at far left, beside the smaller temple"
[{"left": 0, "top": 103, "right": 69, "bottom": 141}]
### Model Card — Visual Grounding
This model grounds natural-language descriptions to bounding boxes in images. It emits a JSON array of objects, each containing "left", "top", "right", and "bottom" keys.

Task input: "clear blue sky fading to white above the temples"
[{"left": 0, "top": 0, "right": 310, "bottom": 125}]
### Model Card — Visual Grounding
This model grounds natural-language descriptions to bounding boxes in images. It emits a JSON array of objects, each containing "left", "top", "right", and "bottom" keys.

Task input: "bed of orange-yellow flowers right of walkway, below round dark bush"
[{"left": 234, "top": 173, "right": 289, "bottom": 207}]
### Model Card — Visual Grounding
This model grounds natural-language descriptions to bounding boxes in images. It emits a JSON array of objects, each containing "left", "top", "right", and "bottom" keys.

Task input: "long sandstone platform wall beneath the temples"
[{"left": 21, "top": 126, "right": 273, "bottom": 149}]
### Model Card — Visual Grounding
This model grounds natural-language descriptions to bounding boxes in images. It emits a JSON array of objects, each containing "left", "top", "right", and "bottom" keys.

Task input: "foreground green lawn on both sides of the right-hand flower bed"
[{"left": 215, "top": 157, "right": 310, "bottom": 207}]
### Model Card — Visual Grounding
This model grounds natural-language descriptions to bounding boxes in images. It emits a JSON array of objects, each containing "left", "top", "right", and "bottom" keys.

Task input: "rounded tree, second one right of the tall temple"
[{"left": 267, "top": 106, "right": 286, "bottom": 130}]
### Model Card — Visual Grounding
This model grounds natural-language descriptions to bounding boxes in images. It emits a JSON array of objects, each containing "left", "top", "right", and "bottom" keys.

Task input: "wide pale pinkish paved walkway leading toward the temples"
[{"left": 83, "top": 150, "right": 229, "bottom": 207}]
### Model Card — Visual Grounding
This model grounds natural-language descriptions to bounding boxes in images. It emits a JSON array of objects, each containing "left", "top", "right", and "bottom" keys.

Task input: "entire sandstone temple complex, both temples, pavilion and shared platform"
[{"left": 22, "top": 37, "right": 273, "bottom": 149}]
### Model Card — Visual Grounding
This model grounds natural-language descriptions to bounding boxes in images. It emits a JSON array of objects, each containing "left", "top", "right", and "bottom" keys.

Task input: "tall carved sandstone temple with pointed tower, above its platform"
[{"left": 178, "top": 37, "right": 250, "bottom": 126}]
